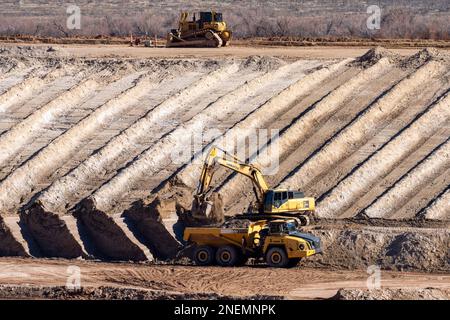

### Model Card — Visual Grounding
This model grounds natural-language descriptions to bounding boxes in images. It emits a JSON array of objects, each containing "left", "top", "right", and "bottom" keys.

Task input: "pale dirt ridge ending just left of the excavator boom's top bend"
[{"left": 177, "top": 59, "right": 351, "bottom": 192}]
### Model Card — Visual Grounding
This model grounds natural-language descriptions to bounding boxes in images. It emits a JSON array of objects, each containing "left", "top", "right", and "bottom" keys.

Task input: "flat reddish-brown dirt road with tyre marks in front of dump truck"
[{"left": 0, "top": 258, "right": 450, "bottom": 299}]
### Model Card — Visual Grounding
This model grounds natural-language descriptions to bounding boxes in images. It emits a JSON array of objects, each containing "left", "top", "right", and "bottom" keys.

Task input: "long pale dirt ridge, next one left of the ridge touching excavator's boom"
[{"left": 86, "top": 61, "right": 324, "bottom": 212}]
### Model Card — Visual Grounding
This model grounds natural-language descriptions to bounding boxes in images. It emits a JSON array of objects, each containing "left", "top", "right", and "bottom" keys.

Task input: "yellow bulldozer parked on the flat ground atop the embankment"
[{"left": 166, "top": 11, "right": 232, "bottom": 48}]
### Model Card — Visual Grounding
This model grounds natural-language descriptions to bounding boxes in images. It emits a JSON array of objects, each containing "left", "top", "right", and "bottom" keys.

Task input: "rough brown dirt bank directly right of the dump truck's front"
[{"left": 303, "top": 226, "right": 450, "bottom": 272}]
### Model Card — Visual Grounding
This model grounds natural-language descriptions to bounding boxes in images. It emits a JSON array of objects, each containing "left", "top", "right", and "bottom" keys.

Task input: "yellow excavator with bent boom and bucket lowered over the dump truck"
[{"left": 191, "top": 147, "right": 315, "bottom": 225}]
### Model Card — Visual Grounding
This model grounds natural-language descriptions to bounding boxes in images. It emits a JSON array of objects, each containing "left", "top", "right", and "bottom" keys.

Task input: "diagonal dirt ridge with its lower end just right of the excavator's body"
[{"left": 317, "top": 93, "right": 450, "bottom": 217}]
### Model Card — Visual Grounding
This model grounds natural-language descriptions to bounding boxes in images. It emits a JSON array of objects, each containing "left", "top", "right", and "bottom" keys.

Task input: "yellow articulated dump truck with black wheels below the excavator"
[{"left": 184, "top": 219, "right": 321, "bottom": 268}]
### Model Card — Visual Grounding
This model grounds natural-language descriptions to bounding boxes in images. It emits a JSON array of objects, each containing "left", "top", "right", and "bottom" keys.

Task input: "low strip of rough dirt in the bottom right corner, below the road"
[{"left": 331, "top": 288, "right": 450, "bottom": 300}]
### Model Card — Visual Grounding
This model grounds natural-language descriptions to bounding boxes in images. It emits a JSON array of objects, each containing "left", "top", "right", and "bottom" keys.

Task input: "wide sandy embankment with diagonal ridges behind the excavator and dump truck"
[{"left": 0, "top": 44, "right": 450, "bottom": 282}]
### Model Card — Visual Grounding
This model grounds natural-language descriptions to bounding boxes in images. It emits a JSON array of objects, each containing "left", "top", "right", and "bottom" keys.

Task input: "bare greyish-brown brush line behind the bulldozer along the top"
[{"left": 0, "top": 7, "right": 450, "bottom": 40}]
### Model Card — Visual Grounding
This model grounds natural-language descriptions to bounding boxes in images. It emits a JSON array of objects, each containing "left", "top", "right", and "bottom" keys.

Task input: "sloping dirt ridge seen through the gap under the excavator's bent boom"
[{"left": 218, "top": 58, "right": 394, "bottom": 212}]
